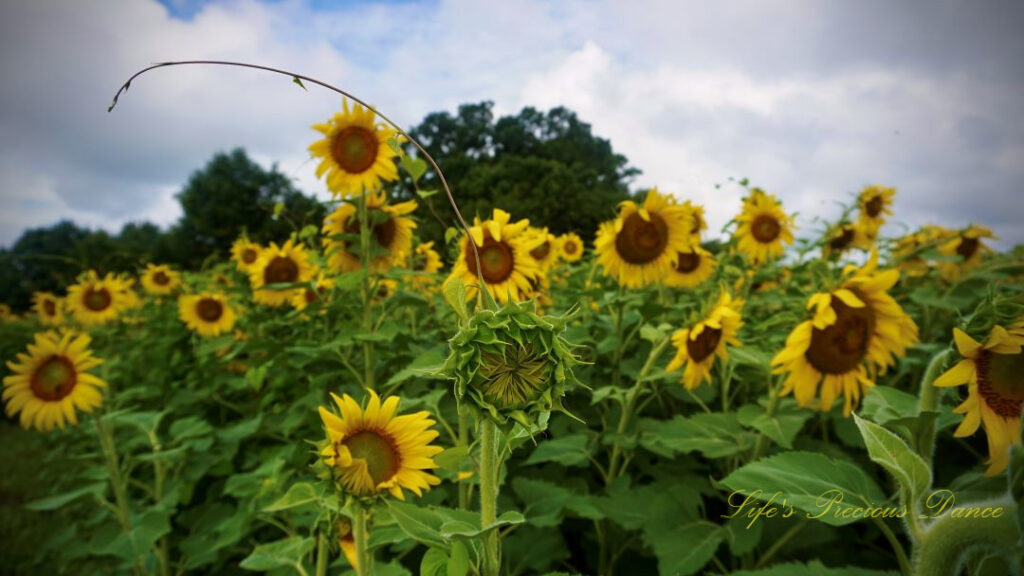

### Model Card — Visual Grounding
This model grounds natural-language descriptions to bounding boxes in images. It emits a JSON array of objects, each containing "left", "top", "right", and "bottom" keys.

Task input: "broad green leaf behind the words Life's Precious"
[{"left": 720, "top": 451, "right": 886, "bottom": 526}]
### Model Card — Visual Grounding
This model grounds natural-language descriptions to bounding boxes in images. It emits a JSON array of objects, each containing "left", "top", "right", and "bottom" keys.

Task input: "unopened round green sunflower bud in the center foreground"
[{"left": 442, "top": 291, "right": 583, "bottom": 430}]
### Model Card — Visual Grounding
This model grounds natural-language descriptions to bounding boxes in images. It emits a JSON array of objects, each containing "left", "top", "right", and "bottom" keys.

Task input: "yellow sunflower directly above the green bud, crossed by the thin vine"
[{"left": 444, "top": 208, "right": 543, "bottom": 302}]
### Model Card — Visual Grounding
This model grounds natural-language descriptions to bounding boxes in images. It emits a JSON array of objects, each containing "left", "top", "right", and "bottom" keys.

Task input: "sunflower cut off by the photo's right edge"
[{"left": 934, "top": 326, "right": 1024, "bottom": 476}]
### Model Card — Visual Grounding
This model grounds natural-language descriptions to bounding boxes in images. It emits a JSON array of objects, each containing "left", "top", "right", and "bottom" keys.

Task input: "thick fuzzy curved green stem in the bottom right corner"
[{"left": 914, "top": 499, "right": 1021, "bottom": 576}]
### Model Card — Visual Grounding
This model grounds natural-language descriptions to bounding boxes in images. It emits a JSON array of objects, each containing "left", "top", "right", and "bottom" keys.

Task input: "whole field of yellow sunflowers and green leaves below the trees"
[{"left": 0, "top": 67, "right": 1024, "bottom": 576}]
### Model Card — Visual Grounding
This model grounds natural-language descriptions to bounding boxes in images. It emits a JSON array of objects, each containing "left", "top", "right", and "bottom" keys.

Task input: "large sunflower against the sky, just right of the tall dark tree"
[{"left": 594, "top": 189, "right": 695, "bottom": 288}]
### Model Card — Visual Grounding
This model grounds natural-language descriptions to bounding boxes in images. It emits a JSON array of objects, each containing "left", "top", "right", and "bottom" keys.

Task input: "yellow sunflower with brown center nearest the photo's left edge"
[{"left": 3, "top": 330, "right": 106, "bottom": 430}]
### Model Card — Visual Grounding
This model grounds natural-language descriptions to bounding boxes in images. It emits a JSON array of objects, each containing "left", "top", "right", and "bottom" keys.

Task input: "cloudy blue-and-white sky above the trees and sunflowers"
[{"left": 0, "top": 0, "right": 1024, "bottom": 247}]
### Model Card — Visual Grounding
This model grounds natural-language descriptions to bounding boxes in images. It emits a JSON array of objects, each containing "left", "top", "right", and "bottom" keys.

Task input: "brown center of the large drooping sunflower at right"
[{"left": 805, "top": 295, "right": 874, "bottom": 374}]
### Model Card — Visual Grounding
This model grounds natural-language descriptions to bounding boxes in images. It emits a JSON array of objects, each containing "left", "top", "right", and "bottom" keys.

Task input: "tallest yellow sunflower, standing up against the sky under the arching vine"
[{"left": 309, "top": 99, "right": 398, "bottom": 198}]
